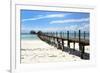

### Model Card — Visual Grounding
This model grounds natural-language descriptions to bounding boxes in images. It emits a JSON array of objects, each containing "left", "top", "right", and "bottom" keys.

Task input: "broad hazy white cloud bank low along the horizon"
[{"left": 21, "top": 24, "right": 89, "bottom": 32}]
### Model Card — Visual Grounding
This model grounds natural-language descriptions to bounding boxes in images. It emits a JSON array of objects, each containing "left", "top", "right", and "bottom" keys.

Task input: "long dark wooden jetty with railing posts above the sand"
[{"left": 31, "top": 30, "right": 90, "bottom": 59}]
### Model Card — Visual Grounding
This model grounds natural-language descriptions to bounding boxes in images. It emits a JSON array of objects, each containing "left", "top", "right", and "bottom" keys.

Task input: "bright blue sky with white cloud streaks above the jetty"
[{"left": 20, "top": 10, "right": 90, "bottom": 33}]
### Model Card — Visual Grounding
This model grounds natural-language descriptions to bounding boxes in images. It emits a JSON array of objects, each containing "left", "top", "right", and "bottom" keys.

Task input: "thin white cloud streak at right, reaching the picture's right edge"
[{"left": 50, "top": 18, "right": 89, "bottom": 24}]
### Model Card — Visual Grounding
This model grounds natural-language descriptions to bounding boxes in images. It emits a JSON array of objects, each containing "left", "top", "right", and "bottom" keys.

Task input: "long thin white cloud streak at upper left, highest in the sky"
[{"left": 22, "top": 14, "right": 66, "bottom": 22}]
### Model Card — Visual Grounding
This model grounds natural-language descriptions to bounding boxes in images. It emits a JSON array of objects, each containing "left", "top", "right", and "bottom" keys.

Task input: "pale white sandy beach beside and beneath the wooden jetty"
[{"left": 21, "top": 40, "right": 89, "bottom": 64}]
